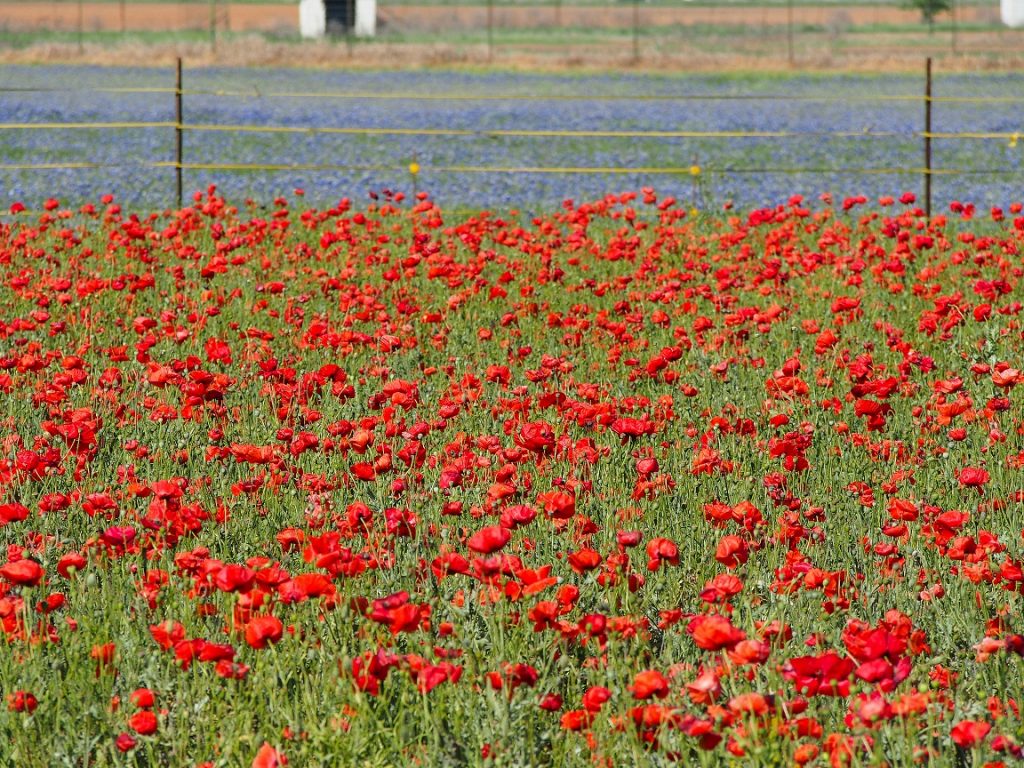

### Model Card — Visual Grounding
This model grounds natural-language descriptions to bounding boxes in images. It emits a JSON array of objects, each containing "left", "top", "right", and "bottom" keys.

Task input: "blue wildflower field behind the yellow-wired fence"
[{"left": 0, "top": 67, "right": 1024, "bottom": 210}]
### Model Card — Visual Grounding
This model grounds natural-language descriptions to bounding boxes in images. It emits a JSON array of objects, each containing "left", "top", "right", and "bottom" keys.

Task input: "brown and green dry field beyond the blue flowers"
[{"left": 0, "top": 0, "right": 1024, "bottom": 70}]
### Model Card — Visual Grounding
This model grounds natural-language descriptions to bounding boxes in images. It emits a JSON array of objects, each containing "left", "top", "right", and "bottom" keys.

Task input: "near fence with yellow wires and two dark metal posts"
[{"left": 0, "top": 59, "right": 1024, "bottom": 211}]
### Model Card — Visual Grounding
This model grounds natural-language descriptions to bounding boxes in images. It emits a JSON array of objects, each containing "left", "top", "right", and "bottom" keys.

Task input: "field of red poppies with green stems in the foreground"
[{"left": 0, "top": 186, "right": 1024, "bottom": 768}]
